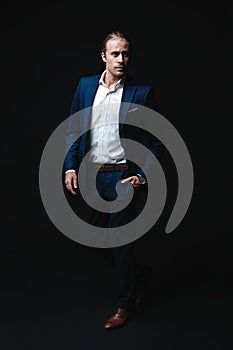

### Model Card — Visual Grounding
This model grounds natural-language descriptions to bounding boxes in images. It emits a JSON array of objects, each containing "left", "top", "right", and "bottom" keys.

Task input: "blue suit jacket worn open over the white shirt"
[{"left": 64, "top": 73, "right": 163, "bottom": 179}]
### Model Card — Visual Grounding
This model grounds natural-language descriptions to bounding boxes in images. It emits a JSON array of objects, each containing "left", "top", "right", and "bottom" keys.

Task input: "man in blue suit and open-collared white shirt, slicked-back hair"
[{"left": 64, "top": 31, "right": 162, "bottom": 329}]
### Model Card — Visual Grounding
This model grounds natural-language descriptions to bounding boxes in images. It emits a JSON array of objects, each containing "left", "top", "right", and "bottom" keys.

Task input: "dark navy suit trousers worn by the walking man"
[{"left": 68, "top": 169, "right": 146, "bottom": 310}]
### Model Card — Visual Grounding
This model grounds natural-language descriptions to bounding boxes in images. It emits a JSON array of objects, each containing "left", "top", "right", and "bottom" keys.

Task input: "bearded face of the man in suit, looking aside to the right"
[{"left": 101, "top": 38, "right": 129, "bottom": 79}]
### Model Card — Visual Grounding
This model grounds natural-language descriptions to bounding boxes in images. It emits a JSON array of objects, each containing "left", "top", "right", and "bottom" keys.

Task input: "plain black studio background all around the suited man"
[{"left": 0, "top": 0, "right": 233, "bottom": 350}]
